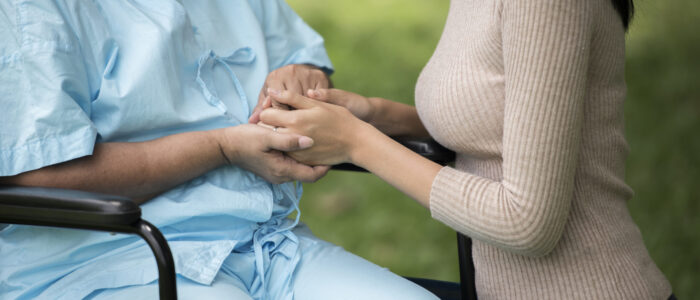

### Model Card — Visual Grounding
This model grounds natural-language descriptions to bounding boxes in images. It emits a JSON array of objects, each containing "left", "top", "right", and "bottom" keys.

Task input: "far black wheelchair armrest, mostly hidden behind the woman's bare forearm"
[{"left": 332, "top": 137, "right": 455, "bottom": 172}]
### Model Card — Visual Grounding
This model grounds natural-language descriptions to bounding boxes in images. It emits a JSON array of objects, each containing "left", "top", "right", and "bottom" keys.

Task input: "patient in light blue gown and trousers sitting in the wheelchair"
[{"left": 0, "top": 0, "right": 435, "bottom": 299}]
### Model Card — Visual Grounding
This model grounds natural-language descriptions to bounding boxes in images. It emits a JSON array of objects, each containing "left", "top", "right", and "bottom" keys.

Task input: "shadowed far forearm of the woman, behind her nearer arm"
[{"left": 368, "top": 98, "right": 430, "bottom": 137}]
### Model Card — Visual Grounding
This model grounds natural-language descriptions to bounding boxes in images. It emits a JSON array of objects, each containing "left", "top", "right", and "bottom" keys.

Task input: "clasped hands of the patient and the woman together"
[{"left": 232, "top": 65, "right": 372, "bottom": 183}]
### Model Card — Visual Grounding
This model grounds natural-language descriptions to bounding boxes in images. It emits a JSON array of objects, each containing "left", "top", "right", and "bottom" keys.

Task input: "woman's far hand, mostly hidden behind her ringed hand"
[{"left": 306, "top": 89, "right": 380, "bottom": 123}]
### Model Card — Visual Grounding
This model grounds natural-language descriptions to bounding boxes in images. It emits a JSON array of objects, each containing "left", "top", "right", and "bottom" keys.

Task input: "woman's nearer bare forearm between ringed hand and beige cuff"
[{"left": 351, "top": 123, "right": 442, "bottom": 208}]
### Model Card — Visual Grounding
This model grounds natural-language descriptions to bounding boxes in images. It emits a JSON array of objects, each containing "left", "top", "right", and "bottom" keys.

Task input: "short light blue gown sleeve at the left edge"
[{"left": 0, "top": 3, "right": 97, "bottom": 176}]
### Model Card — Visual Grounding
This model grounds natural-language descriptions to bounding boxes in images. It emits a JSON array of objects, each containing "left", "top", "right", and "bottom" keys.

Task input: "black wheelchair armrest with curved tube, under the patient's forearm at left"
[{"left": 0, "top": 186, "right": 177, "bottom": 299}]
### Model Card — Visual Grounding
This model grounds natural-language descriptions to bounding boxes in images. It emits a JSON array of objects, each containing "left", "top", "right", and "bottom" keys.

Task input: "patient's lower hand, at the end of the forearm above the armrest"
[{"left": 216, "top": 124, "right": 329, "bottom": 184}]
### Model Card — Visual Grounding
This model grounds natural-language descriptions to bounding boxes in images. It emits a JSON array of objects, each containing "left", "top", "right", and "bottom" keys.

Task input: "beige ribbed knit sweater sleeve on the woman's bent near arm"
[{"left": 430, "top": 0, "right": 594, "bottom": 256}]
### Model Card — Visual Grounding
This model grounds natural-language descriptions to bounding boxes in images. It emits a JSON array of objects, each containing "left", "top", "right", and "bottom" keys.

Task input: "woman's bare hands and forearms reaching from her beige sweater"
[{"left": 260, "top": 89, "right": 442, "bottom": 207}]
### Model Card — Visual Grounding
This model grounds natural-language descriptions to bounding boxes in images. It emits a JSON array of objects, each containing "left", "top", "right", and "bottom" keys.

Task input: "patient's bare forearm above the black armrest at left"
[{"left": 0, "top": 131, "right": 226, "bottom": 203}]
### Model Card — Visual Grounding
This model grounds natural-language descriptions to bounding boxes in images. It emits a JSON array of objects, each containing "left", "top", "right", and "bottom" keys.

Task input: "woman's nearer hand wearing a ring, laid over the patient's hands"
[{"left": 260, "top": 90, "right": 375, "bottom": 165}]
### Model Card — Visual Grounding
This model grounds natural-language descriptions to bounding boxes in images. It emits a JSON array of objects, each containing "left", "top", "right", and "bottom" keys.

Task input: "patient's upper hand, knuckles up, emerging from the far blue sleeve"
[{"left": 248, "top": 64, "right": 330, "bottom": 124}]
